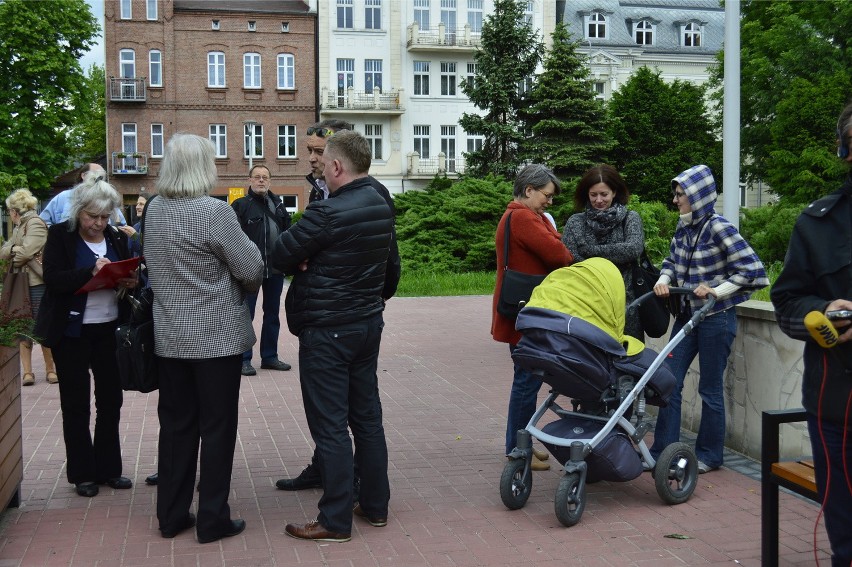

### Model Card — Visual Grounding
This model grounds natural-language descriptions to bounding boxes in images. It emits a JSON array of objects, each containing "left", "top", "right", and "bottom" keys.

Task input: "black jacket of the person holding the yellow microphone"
[{"left": 771, "top": 178, "right": 852, "bottom": 429}]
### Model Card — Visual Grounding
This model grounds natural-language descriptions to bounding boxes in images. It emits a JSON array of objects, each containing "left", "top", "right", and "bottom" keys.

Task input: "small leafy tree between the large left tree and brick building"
[{"left": 69, "top": 65, "right": 106, "bottom": 166}]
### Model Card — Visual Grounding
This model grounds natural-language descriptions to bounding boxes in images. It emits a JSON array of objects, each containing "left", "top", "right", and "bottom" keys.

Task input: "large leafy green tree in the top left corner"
[{"left": 0, "top": 0, "right": 99, "bottom": 192}]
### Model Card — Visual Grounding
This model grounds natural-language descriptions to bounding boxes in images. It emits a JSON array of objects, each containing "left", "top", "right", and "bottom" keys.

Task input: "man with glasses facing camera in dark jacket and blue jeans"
[{"left": 231, "top": 165, "right": 290, "bottom": 376}]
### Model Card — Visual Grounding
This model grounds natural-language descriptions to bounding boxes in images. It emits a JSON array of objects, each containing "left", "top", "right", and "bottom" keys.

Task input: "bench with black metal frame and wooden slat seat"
[{"left": 760, "top": 409, "right": 819, "bottom": 567}]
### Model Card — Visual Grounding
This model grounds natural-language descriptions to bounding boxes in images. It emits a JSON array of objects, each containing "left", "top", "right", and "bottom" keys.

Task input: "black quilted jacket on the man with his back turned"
[{"left": 269, "top": 177, "right": 398, "bottom": 336}]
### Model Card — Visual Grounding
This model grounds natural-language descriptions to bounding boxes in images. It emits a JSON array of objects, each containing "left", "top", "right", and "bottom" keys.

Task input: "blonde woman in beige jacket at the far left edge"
[{"left": 0, "top": 189, "right": 59, "bottom": 386}]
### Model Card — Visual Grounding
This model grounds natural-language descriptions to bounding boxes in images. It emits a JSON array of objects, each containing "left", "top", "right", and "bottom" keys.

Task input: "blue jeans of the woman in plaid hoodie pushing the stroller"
[{"left": 651, "top": 307, "right": 737, "bottom": 468}]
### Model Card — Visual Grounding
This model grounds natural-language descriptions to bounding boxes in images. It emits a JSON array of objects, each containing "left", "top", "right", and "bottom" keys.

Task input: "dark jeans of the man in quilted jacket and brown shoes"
[{"left": 299, "top": 314, "right": 390, "bottom": 534}]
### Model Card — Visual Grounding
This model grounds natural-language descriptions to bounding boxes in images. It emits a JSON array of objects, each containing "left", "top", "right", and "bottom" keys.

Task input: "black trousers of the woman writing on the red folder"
[{"left": 53, "top": 321, "right": 124, "bottom": 484}]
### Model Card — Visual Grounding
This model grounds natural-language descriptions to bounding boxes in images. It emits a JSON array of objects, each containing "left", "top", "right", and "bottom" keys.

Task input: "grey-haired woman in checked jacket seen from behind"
[{"left": 145, "top": 134, "right": 263, "bottom": 543}]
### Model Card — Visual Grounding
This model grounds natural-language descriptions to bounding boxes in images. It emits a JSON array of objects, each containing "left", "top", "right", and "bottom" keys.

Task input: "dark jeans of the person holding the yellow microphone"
[{"left": 808, "top": 413, "right": 852, "bottom": 567}]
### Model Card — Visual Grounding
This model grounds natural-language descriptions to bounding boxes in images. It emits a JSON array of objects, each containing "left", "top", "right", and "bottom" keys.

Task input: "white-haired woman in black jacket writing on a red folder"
[{"left": 35, "top": 178, "right": 136, "bottom": 496}]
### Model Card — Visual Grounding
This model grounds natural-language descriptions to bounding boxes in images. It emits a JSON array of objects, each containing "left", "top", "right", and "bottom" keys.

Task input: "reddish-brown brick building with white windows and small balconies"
[{"left": 104, "top": 0, "right": 317, "bottom": 210}]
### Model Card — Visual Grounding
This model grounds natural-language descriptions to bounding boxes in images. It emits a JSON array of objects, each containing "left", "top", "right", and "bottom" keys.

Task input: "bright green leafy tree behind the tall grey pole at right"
[{"left": 712, "top": 0, "right": 852, "bottom": 203}]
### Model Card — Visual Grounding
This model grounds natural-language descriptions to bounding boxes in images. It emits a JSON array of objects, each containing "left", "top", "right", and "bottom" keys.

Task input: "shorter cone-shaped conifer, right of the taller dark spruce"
[{"left": 521, "top": 23, "right": 612, "bottom": 178}]
